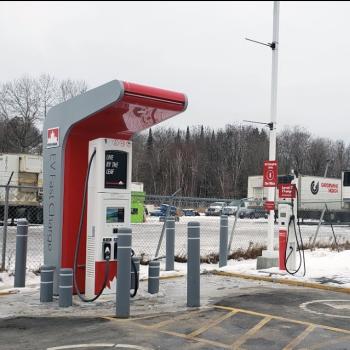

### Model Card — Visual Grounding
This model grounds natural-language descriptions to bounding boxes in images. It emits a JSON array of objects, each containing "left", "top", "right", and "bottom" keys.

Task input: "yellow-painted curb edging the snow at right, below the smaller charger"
[{"left": 212, "top": 270, "right": 350, "bottom": 294}]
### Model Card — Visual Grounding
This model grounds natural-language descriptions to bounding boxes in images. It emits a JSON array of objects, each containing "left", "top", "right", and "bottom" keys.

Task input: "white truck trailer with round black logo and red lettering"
[{"left": 247, "top": 171, "right": 350, "bottom": 222}]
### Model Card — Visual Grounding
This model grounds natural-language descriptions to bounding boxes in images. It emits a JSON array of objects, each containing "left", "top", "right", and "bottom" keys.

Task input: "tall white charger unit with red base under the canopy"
[{"left": 85, "top": 138, "right": 132, "bottom": 298}]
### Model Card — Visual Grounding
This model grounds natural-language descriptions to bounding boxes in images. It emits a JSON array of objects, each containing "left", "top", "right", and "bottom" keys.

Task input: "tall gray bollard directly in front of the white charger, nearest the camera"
[{"left": 116, "top": 227, "right": 132, "bottom": 318}]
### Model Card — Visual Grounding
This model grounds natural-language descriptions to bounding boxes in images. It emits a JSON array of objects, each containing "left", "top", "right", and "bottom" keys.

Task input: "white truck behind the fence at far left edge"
[{"left": 0, "top": 153, "right": 43, "bottom": 224}]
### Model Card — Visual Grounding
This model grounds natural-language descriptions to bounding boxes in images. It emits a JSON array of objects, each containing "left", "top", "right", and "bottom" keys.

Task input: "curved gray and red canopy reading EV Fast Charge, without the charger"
[{"left": 43, "top": 80, "right": 187, "bottom": 290}]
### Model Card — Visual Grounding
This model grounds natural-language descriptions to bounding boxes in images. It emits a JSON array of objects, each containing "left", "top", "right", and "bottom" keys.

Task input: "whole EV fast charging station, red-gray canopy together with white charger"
[{"left": 43, "top": 80, "right": 187, "bottom": 298}]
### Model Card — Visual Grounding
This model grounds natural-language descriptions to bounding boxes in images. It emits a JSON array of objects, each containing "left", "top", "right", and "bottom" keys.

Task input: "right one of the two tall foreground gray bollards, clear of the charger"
[{"left": 187, "top": 221, "right": 200, "bottom": 307}]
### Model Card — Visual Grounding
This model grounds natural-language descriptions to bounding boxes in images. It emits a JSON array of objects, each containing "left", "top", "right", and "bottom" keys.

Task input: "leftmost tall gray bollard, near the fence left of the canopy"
[{"left": 15, "top": 219, "right": 28, "bottom": 287}]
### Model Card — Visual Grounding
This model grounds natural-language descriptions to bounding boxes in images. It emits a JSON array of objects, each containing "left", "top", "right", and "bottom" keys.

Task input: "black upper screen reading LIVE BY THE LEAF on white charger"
[{"left": 105, "top": 150, "right": 128, "bottom": 189}]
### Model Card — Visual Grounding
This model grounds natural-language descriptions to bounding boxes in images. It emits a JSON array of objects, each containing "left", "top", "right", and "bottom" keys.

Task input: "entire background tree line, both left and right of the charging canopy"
[{"left": 0, "top": 74, "right": 350, "bottom": 198}]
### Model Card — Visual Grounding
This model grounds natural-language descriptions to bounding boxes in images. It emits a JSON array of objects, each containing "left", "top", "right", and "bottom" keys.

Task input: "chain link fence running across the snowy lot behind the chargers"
[{"left": 0, "top": 186, "right": 350, "bottom": 270}]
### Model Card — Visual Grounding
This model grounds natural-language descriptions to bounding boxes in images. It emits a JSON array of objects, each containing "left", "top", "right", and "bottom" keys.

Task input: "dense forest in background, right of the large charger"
[{"left": 133, "top": 124, "right": 350, "bottom": 198}]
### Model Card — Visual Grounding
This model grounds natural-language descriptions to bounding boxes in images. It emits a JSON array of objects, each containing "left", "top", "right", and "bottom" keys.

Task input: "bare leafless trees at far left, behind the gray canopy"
[{"left": 0, "top": 74, "right": 87, "bottom": 152}]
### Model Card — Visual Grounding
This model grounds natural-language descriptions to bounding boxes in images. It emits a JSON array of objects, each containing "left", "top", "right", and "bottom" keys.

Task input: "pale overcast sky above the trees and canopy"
[{"left": 0, "top": 1, "right": 350, "bottom": 142}]
